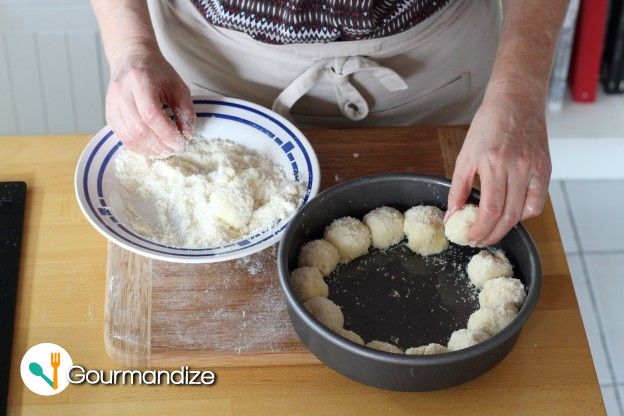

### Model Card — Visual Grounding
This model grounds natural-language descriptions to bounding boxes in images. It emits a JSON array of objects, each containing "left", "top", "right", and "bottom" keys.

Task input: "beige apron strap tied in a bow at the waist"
[{"left": 273, "top": 56, "right": 407, "bottom": 120}]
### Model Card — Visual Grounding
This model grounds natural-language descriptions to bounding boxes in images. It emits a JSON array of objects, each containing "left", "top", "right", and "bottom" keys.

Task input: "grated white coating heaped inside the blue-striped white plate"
[{"left": 115, "top": 138, "right": 306, "bottom": 247}]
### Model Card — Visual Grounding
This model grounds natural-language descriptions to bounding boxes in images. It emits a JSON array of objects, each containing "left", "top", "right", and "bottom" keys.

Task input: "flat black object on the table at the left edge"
[{"left": 0, "top": 182, "right": 26, "bottom": 415}]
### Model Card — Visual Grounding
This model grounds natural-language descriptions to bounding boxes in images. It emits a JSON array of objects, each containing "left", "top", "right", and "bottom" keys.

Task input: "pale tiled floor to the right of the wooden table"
[{"left": 550, "top": 180, "right": 624, "bottom": 416}]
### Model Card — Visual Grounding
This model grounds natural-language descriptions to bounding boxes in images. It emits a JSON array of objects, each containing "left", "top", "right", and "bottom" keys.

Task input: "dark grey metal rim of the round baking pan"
[{"left": 277, "top": 173, "right": 542, "bottom": 367}]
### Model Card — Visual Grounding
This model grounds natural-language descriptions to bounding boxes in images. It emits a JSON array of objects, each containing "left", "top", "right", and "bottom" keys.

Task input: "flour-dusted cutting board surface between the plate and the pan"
[{"left": 151, "top": 246, "right": 298, "bottom": 354}]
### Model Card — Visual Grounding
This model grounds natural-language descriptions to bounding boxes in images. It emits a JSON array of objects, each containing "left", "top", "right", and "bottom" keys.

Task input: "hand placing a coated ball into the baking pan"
[{"left": 445, "top": 86, "right": 551, "bottom": 247}]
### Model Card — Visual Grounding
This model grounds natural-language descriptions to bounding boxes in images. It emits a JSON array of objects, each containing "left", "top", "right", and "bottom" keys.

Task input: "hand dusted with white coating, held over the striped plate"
[{"left": 106, "top": 44, "right": 195, "bottom": 158}]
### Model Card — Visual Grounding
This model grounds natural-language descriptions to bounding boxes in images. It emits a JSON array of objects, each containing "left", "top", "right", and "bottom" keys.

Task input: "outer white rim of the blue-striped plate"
[{"left": 74, "top": 94, "right": 321, "bottom": 264}]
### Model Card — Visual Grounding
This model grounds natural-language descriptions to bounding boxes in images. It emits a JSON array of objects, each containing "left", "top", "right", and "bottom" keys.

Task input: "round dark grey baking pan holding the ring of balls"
[{"left": 278, "top": 174, "right": 541, "bottom": 391}]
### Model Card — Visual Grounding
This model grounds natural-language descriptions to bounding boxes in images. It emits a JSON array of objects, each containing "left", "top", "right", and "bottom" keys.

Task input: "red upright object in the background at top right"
[{"left": 568, "top": 0, "right": 608, "bottom": 103}]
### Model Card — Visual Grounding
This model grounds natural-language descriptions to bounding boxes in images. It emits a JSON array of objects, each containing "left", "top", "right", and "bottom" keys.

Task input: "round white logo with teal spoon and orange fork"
[{"left": 20, "top": 343, "right": 73, "bottom": 396}]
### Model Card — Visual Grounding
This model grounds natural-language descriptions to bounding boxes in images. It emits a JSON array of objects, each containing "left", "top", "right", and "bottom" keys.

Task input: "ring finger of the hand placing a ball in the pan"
[{"left": 480, "top": 171, "right": 529, "bottom": 246}]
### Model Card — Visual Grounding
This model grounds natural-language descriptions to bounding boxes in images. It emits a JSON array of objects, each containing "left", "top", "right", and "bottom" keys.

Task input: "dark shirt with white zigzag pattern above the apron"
[{"left": 192, "top": 0, "right": 452, "bottom": 45}]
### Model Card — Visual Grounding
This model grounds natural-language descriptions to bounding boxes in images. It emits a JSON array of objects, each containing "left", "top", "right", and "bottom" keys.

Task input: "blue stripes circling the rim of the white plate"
[{"left": 83, "top": 100, "right": 313, "bottom": 257}]
